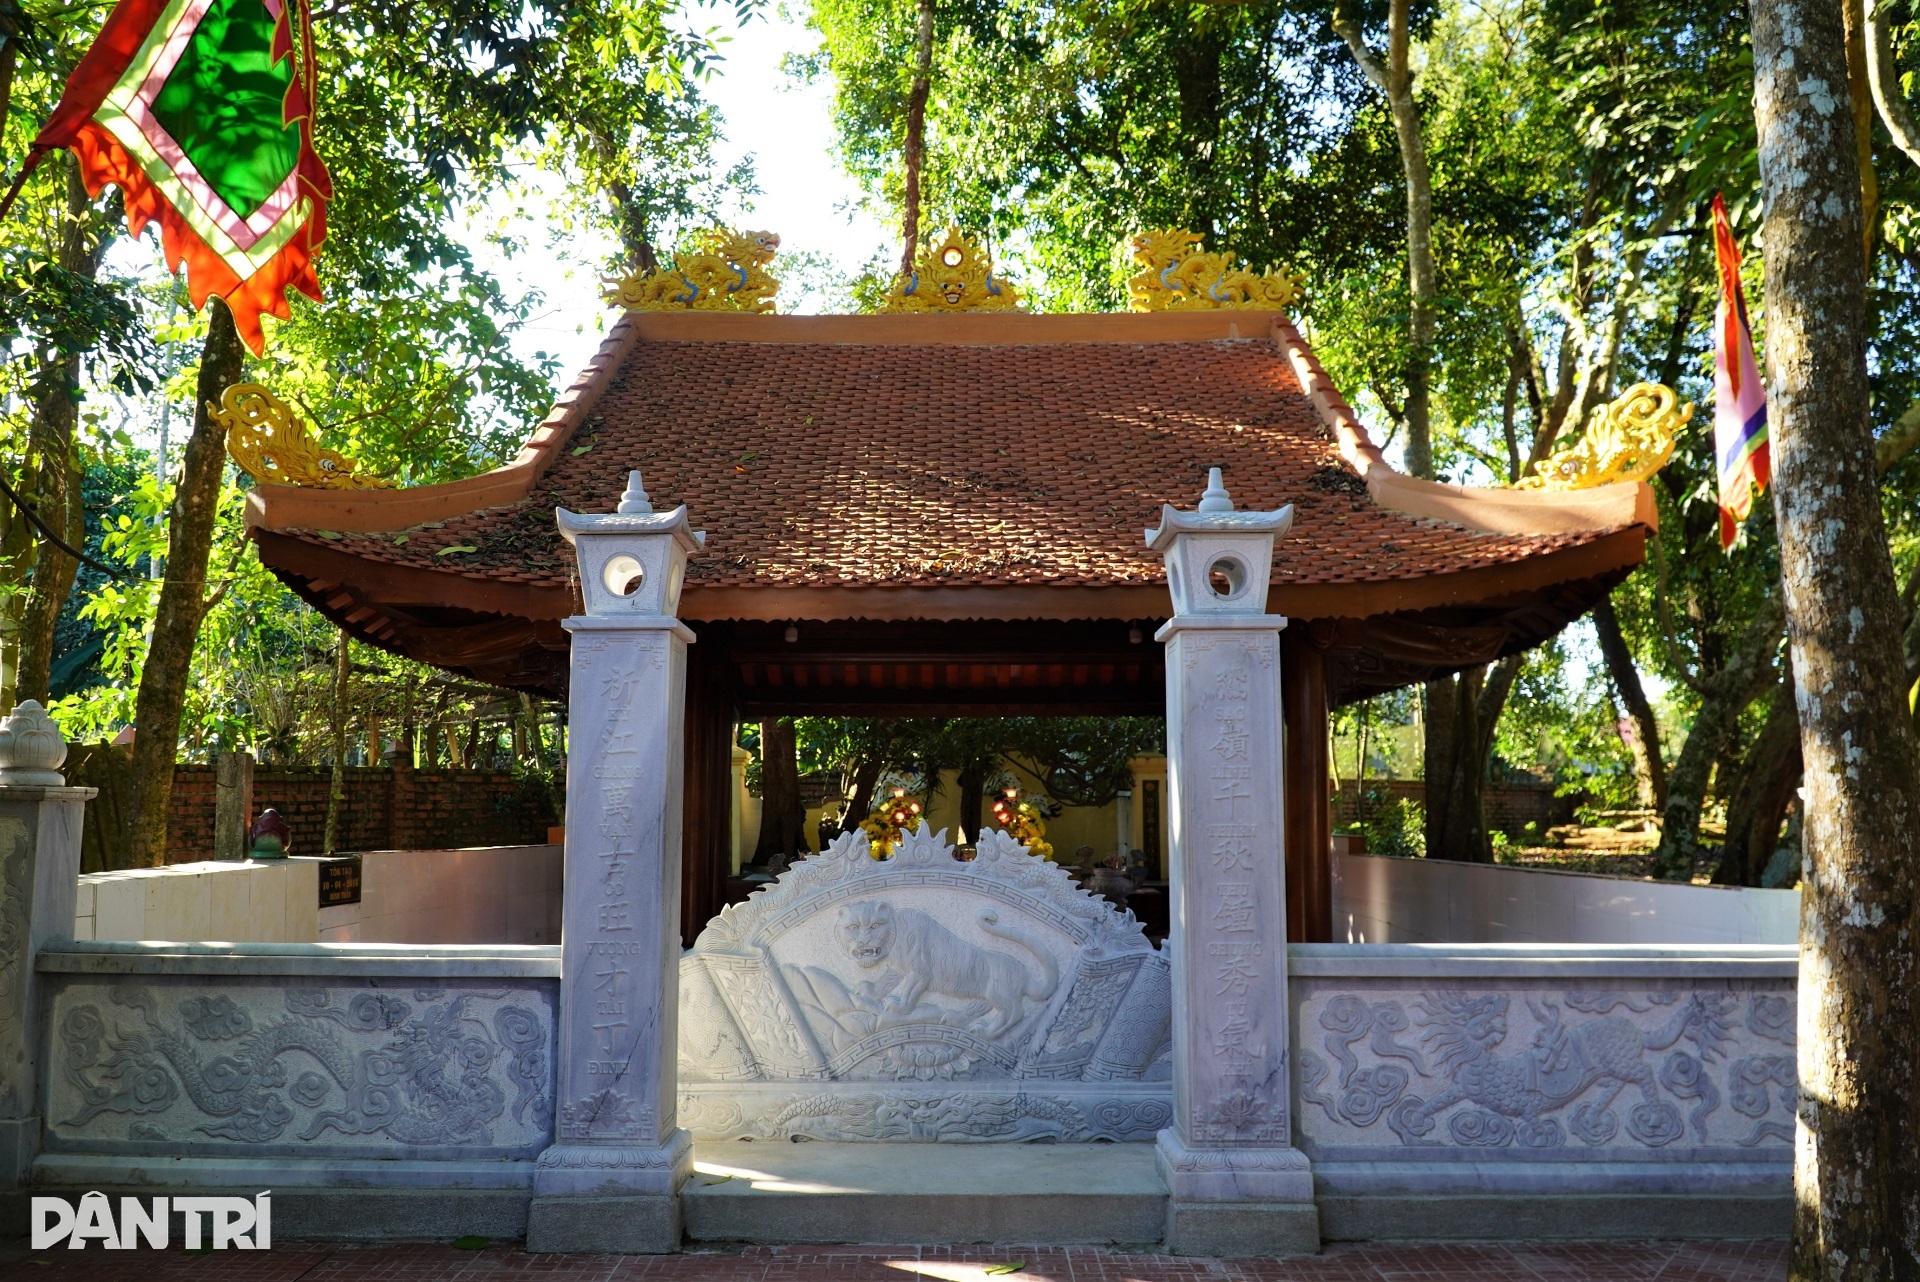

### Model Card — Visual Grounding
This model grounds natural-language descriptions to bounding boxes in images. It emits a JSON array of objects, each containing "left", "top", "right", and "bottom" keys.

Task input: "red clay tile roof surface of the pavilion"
[{"left": 257, "top": 317, "right": 1619, "bottom": 610}]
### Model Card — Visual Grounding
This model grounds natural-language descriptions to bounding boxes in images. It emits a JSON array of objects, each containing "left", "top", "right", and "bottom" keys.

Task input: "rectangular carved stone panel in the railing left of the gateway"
[{"left": 46, "top": 977, "right": 555, "bottom": 1157}]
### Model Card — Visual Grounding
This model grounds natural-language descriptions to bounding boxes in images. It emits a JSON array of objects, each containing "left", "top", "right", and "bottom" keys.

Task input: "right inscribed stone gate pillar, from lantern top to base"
[{"left": 1146, "top": 468, "right": 1319, "bottom": 1255}]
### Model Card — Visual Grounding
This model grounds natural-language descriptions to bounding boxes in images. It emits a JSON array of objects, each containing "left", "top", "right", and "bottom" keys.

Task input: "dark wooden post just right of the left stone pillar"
[{"left": 680, "top": 624, "right": 733, "bottom": 946}]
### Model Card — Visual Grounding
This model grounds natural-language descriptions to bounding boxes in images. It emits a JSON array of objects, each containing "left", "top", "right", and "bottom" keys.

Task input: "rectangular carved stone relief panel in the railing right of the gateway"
[{"left": 1294, "top": 981, "right": 1795, "bottom": 1161}]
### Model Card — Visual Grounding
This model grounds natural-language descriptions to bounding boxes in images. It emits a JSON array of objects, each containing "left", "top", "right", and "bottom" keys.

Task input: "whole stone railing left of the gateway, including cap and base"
[{"left": 35, "top": 942, "right": 559, "bottom": 1236}]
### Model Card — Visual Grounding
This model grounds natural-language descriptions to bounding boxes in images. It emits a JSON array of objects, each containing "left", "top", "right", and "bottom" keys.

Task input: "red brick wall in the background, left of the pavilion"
[{"left": 167, "top": 766, "right": 559, "bottom": 864}]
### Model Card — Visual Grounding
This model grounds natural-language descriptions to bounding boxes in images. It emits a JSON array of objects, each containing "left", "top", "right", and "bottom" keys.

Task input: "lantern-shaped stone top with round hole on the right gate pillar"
[{"left": 1146, "top": 468, "right": 1294, "bottom": 614}]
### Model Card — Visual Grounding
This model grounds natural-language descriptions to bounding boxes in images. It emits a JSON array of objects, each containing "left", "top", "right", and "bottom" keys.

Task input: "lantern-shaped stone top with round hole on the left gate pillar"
[{"left": 553, "top": 470, "right": 707, "bottom": 616}]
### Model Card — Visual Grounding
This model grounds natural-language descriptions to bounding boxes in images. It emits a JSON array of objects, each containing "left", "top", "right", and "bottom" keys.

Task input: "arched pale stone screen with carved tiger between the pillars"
[{"left": 680, "top": 831, "right": 1171, "bottom": 1140}]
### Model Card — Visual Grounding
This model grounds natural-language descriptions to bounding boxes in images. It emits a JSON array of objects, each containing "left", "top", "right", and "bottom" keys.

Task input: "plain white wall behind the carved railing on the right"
[{"left": 1332, "top": 854, "right": 1799, "bottom": 944}]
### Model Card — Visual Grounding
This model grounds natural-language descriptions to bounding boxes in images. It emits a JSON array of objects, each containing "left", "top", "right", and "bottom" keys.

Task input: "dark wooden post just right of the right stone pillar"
[{"left": 1281, "top": 622, "right": 1332, "bottom": 944}]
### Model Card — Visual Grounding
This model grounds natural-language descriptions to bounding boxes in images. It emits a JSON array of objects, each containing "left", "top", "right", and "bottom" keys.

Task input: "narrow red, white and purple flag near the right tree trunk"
[{"left": 1713, "top": 194, "right": 1772, "bottom": 551}]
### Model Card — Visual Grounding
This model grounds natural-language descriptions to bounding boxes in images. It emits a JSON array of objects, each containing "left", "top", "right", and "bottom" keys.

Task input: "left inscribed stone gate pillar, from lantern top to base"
[{"left": 526, "top": 472, "right": 705, "bottom": 1251}]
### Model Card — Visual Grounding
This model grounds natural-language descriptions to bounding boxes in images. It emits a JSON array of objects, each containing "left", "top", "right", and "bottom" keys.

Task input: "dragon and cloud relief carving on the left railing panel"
[{"left": 58, "top": 983, "right": 553, "bottom": 1148}]
